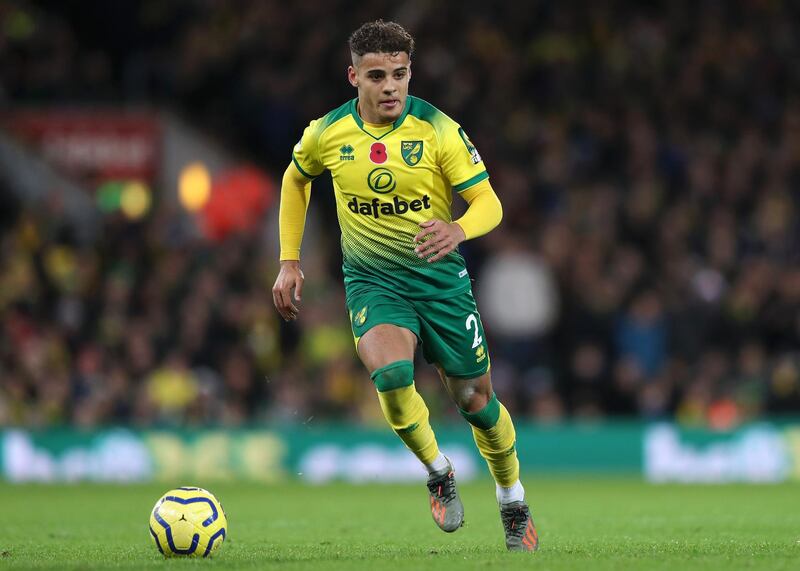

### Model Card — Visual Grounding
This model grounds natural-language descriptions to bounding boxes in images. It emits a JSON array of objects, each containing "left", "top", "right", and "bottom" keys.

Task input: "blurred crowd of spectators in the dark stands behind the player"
[{"left": 0, "top": 0, "right": 800, "bottom": 428}]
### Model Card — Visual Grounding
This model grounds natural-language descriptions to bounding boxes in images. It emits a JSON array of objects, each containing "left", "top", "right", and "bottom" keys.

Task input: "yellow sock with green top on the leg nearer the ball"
[{"left": 371, "top": 361, "right": 439, "bottom": 465}]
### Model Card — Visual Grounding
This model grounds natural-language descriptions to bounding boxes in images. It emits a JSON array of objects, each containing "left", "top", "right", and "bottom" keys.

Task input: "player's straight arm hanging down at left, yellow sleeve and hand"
[{"left": 272, "top": 162, "right": 311, "bottom": 321}]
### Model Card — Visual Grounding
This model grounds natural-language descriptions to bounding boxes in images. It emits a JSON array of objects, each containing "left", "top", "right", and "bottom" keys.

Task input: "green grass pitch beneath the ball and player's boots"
[{"left": 0, "top": 477, "right": 800, "bottom": 571}]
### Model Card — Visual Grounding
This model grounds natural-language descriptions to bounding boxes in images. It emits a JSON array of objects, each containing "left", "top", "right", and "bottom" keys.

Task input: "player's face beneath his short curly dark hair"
[{"left": 347, "top": 52, "right": 411, "bottom": 124}]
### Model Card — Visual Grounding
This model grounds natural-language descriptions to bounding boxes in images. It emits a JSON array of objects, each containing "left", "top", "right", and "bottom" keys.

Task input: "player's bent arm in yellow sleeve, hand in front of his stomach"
[{"left": 414, "top": 179, "right": 503, "bottom": 262}]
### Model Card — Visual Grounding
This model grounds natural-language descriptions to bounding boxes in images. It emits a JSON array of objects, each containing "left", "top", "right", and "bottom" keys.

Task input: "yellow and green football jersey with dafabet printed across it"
[{"left": 292, "top": 96, "right": 489, "bottom": 299}]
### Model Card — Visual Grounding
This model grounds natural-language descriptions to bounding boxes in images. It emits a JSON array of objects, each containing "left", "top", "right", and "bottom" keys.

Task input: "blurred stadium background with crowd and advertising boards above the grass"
[{"left": 0, "top": 0, "right": 800, "bottom": 488}]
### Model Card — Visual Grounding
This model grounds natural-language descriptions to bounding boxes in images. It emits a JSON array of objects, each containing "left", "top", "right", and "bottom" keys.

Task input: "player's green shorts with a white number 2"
[{"left": 347, "top": 285, "right": 489, "bottom": 379}]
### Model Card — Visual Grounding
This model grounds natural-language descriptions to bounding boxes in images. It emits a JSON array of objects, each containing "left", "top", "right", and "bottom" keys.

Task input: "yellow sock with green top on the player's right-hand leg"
[{"left": 461, "top": 395, "right": 519, "bottom": 488}]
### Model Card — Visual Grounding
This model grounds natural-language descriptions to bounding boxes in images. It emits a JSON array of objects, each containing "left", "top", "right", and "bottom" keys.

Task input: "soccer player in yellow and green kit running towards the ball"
[{"left": 272, "top": 20, "right": 538, "bottom": 551}]
